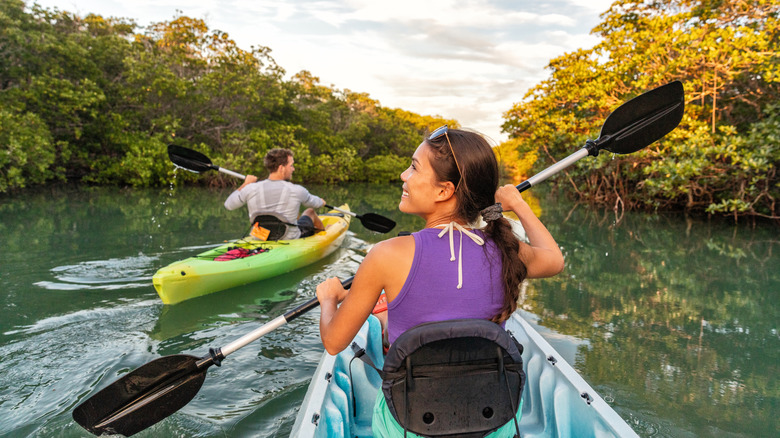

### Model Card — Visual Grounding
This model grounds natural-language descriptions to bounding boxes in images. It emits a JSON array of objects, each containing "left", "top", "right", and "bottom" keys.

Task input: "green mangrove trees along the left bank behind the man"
[{"left": 0, "top": 0, "right": 446, "bottom": 193}]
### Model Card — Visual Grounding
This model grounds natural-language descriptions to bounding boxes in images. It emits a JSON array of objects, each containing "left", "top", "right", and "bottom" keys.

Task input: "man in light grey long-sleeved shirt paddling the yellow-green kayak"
[{"left": 225, "top": 148, "right": 325, "bottom": 240}]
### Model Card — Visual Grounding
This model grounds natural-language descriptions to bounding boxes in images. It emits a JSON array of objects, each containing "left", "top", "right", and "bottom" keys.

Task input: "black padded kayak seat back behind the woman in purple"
[{"left": 354, "top": 319, "right": 526, "bottom": 438}]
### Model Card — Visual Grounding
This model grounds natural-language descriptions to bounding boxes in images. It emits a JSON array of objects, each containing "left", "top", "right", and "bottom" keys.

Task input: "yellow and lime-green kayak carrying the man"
[{"left": 152, "top": 205, "right": 351, "bottom": 304}]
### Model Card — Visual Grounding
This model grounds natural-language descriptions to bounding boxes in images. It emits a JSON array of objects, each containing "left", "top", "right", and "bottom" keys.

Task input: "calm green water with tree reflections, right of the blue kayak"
[{"left": 524, "top": 192, "right": 780, "bottom": 436}]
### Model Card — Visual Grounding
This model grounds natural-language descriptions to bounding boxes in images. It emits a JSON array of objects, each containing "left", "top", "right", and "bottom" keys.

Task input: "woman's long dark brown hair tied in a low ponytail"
[{"left": 425, "top": 129, "right": 528, "bottom": 323}]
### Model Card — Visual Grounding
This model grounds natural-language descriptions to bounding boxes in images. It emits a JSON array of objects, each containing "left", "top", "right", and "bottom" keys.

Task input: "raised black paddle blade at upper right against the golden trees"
[{"left": 595, "top": 81, "right": 685, "bottom": 154}]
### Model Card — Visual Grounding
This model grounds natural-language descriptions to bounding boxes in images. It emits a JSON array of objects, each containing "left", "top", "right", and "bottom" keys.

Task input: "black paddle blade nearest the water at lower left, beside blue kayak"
[{"left": 73, "top": 354, "right": 213, "bottom": 436}]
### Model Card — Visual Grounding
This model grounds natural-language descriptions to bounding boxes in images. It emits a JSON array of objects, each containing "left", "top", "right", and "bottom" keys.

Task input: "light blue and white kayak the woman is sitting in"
[{"left": 290, "top": 313, "right": 638, "bottom": 437}]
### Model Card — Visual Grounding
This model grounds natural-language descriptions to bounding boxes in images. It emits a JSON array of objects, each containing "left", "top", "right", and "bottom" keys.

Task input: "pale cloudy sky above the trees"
[{"left": 33, "top": 0, "right": 611, "bottom": 143}]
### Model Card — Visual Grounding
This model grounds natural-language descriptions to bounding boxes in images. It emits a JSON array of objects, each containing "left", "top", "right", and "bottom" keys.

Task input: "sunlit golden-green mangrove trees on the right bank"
[{"left": 503, "top": 0, "right": 780, "bottom": 219}]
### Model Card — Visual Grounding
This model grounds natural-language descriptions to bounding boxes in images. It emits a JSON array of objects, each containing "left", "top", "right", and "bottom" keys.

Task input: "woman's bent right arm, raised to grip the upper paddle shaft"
[{"left": 496, "top": 184, "right": 564, "bottom": 278}]
